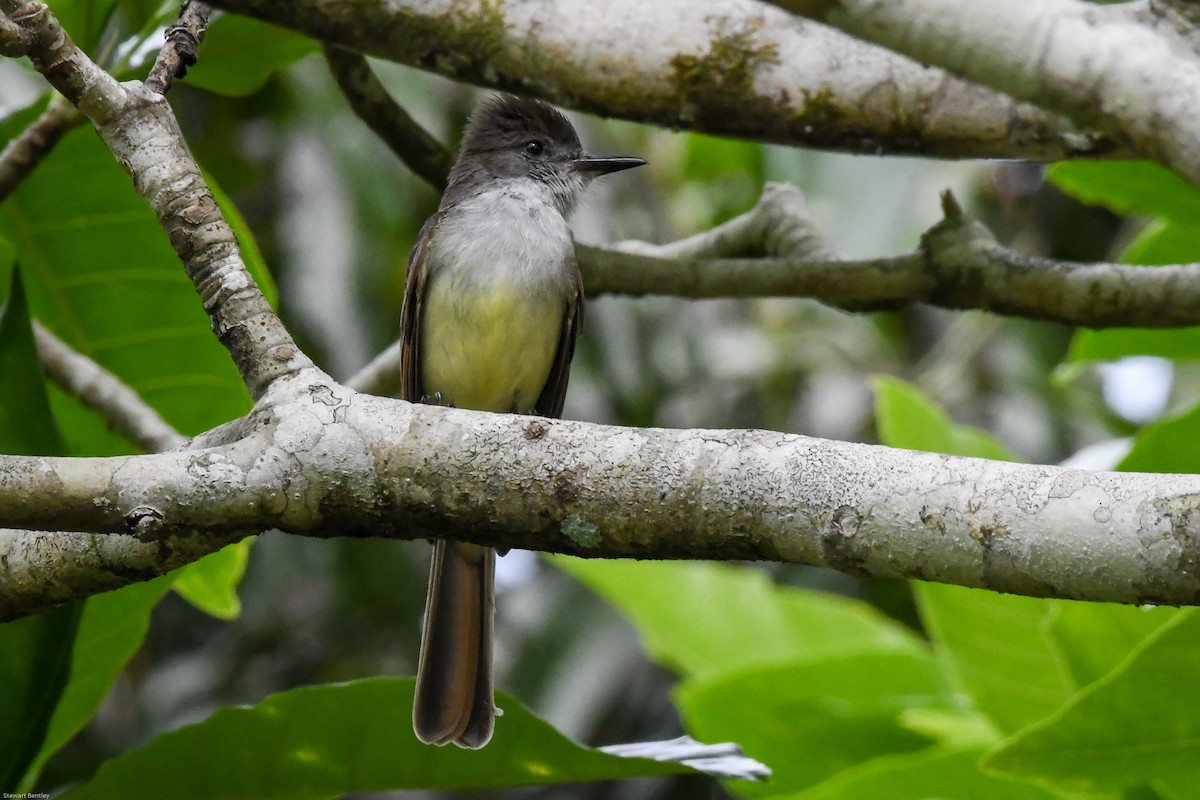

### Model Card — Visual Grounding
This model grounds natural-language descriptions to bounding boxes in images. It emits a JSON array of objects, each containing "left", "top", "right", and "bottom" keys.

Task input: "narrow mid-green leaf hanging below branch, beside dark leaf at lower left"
[{"left": 20, "top": 576, "right": 170, "bottom": 790}]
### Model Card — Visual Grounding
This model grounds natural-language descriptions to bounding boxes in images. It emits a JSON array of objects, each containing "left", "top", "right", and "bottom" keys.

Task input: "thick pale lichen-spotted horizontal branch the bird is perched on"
[{"left": 0, "top": 371, "right": 1200, "bottom": 616}]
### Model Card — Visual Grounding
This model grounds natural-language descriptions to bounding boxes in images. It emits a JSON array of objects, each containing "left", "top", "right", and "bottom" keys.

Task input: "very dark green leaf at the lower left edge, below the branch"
[{"left": 0, "top": 603, "right": 83, "bottom": 788}]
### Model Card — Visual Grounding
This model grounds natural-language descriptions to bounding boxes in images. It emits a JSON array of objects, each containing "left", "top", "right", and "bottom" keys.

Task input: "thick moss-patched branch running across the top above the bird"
[{"left": 208, "top": 0, "right": 1129, "bottom": 161}]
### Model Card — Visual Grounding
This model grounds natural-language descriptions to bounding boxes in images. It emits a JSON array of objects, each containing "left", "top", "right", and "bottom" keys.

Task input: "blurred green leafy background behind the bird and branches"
[{"left": 0, "top": 0, "right": 1200, "bottom": 800}]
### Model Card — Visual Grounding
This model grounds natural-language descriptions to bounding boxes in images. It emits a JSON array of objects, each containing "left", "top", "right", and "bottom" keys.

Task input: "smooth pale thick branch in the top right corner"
[{"left": 772, "top": 0, "right": 1200, "bottom": 182}]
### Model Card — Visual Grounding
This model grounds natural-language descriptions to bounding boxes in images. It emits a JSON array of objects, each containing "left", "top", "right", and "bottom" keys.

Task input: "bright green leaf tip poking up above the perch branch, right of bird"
[{"left": 871, "top": 375, "right": 1015, "bottom": 461}]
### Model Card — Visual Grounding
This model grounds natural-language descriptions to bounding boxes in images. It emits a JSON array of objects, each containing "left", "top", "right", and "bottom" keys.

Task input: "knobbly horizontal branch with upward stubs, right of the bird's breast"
[{"left": 576, "top": 185, "right": 1200, "bottom": 327}]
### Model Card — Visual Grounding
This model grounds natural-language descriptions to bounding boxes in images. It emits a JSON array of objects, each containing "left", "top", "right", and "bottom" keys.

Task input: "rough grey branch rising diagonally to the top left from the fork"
[{"left": 0, "top": 0, "right": 311, "bottom": 398}]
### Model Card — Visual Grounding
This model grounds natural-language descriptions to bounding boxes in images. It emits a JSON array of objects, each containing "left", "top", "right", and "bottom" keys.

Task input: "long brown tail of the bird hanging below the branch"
[{"left": 413, "top": 540, "right": 496, "bottom": 750}]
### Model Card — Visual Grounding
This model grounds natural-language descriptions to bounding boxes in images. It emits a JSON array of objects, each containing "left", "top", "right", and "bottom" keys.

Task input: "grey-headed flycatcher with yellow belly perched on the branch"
[{"left": 401, "top": 96, "right": 646, "bottom": 748}]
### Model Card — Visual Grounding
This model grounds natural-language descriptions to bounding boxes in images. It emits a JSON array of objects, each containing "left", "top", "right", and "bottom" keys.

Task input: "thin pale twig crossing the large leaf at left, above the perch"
[{"left": 34, "top": 321, "right": 185, "bottom": 452}]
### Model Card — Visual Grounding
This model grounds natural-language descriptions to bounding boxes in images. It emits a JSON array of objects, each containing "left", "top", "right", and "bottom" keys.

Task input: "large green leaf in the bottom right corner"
[{"left": 984, "top": 608, "right": 1200, "bottom": 790}]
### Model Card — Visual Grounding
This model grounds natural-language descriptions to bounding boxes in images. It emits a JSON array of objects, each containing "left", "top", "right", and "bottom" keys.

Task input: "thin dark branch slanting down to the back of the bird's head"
[{"left": 325, "top": 46, "right": 454, "bottom": 191}]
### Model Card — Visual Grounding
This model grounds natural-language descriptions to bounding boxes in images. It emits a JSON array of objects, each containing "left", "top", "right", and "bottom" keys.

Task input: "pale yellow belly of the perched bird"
[{"left": 421, "top": 281, "right": 565, "bottom": 414}]
